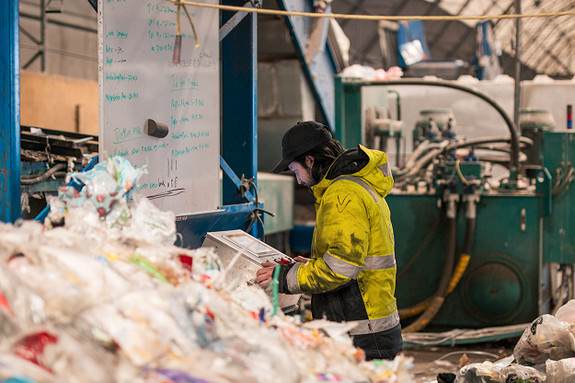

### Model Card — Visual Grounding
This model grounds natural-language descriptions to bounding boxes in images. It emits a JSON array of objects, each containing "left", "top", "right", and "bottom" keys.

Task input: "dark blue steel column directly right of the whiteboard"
[{"left": 220, "top": 0, "right": 258, "bottom": 205}]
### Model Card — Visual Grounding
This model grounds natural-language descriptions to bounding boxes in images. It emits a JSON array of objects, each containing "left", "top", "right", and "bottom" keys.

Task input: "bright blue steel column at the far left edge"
[{"left": 0, "top": 0, "right": 20, "bottom": 222}]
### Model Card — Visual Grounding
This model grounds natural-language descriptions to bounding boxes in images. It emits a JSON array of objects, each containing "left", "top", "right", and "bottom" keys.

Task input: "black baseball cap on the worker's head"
[{"left": 272, "top": 121, "right": 332, "bottom": 173}]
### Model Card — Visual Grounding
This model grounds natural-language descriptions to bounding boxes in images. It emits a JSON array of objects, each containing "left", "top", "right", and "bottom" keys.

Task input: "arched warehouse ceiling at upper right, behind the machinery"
[{"left": 332, "top": 0, "right": 575, "bottom": 79}]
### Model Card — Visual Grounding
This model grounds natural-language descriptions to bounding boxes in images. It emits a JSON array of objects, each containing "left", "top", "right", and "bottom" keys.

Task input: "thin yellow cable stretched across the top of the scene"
[{"left": 170, "top": 0, "right": 575, "bottom": 21}]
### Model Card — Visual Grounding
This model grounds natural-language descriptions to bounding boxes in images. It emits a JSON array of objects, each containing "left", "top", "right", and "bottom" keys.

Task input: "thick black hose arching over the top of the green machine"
[{"left": 356, "top": 79, "right": 519, "bottom": 176}]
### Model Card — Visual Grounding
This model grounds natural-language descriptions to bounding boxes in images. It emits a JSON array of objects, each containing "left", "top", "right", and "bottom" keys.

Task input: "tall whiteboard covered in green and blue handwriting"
[{"left": 98, "top": 0, "right": 220, "bottom": 215}]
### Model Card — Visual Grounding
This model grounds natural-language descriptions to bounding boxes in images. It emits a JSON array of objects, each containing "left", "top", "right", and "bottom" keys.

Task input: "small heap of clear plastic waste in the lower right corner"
[{"left": 455, "top": 300, "right": 575, "bottom": 383}]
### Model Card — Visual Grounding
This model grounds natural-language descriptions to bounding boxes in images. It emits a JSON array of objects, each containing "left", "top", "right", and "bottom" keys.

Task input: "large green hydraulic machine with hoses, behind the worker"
[{"left": 335, "top": 78, "right": 575, "bottom": 331}]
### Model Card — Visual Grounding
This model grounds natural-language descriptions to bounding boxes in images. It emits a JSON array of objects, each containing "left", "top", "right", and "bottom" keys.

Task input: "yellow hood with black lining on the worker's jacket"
[{"left": 311, "top": 145, "right": 393, "bottom": 199}]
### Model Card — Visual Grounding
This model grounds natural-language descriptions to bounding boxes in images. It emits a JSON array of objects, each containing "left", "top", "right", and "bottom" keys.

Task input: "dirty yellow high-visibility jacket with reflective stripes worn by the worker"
[{"left": 286, "top": 146, "right": 399, "bottom": 335}]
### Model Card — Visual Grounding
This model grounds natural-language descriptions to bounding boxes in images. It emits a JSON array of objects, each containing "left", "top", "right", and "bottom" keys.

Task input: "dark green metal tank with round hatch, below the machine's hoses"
[{"left": 386, "top": 194, "right": 543, "bottom": 329}]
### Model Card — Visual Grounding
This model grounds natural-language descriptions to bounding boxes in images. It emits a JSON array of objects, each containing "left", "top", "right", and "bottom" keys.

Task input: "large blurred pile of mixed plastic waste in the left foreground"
[{"left": 0, "top": 157, "right": 413, "bottom": 383}]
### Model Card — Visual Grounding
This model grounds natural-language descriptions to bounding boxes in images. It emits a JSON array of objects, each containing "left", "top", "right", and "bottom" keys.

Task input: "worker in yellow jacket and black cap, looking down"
[{"left": 256, "top": 121, "right": 403, "bottom": 360}]
